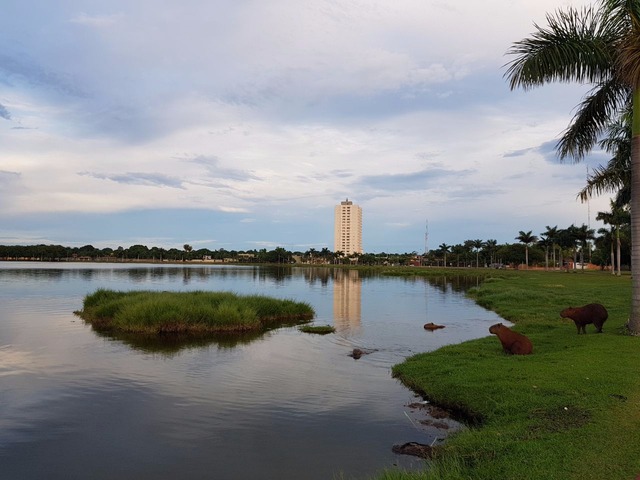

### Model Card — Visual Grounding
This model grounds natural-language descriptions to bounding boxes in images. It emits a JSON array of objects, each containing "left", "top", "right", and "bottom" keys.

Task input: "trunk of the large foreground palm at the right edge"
[{"left": 629, "top": 92, "right": 640, "bottom": 335}]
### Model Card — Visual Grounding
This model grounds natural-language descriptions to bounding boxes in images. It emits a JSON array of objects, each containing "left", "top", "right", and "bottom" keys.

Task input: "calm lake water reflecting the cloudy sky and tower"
[{"left": 0, "top": 262, "right": 499, "bottom": 480}]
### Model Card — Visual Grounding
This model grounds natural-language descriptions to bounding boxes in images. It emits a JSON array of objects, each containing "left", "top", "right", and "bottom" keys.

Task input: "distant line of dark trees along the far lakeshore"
[{"left": 0, "top": 218, "right": 631, "bottom": 274}]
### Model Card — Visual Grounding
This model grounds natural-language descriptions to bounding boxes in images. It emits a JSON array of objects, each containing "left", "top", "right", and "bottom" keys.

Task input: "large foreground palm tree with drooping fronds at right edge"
[{"left": 506, "top": 0, "right": 640, "bottom": 335}]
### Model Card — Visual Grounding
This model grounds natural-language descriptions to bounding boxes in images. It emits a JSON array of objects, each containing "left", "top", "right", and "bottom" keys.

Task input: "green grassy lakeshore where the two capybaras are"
[{"left": 378, "top": 271, "right": 640, "bottom": 480}]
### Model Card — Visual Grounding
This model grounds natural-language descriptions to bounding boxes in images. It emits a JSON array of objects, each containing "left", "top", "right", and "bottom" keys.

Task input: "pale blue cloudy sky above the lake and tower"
[{"left": 0, "top": 0, "right": 610, "bottom": 253}]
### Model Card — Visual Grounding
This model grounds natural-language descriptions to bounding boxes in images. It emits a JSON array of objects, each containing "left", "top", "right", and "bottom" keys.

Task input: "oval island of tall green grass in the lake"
[{"left": 76, "top": 289, "right": 315, "bottom": 334}]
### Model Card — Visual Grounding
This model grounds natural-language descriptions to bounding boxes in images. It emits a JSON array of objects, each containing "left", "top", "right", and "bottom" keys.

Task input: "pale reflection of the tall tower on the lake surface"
[{"left": 333, "top": 269, "right": 362, "bottom": 333}]
